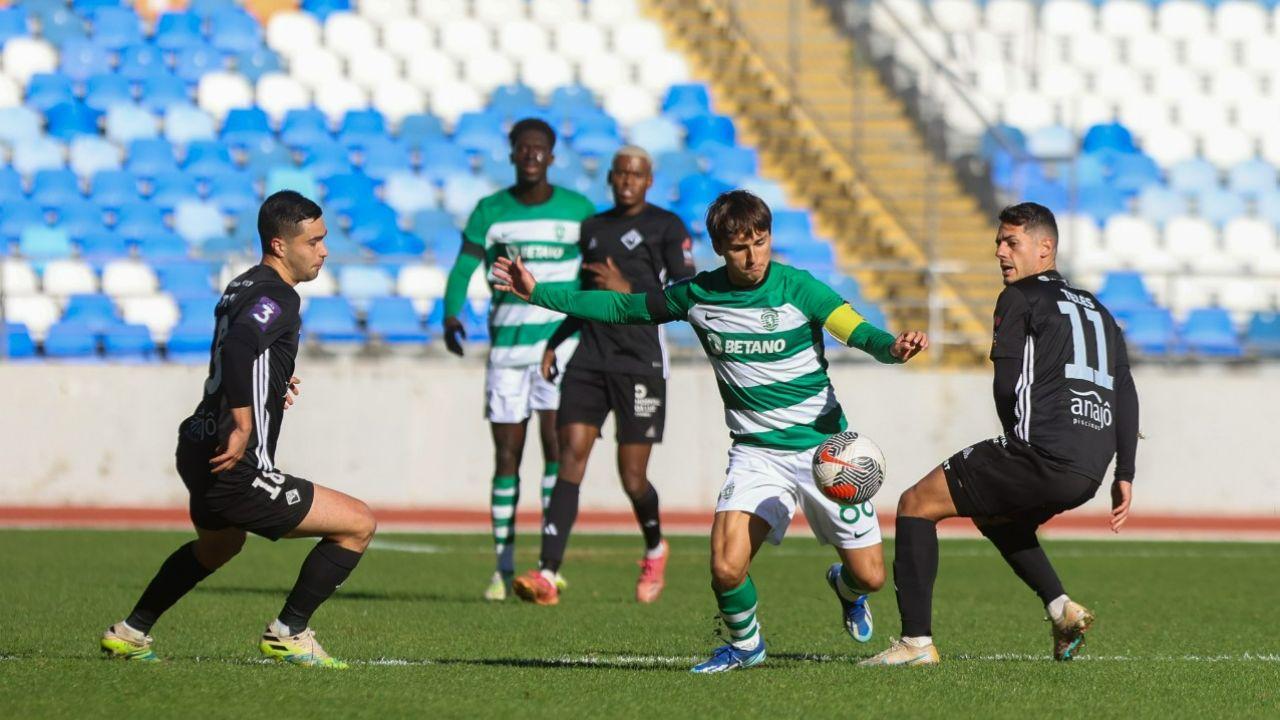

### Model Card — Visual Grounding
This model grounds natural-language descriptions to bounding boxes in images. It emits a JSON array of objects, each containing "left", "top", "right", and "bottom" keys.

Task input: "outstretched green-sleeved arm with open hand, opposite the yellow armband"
[{"left": 493, "top": 258, "right": 672, "bottom": 325}]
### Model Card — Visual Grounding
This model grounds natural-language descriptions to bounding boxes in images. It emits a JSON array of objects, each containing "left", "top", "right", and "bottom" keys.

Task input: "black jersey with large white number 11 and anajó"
[{"left": 991, "top": 270, "right": 1137, "bottom": 480}]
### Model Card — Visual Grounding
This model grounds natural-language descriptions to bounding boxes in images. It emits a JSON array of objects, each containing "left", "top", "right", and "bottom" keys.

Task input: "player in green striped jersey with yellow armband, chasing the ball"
[{"left": 493, "top": 191, "right": 928, "bottom": 673}]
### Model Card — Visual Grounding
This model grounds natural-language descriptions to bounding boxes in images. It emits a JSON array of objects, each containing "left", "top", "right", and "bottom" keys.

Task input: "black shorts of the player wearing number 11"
[{"left": 942, "top": 436, "right": 1100, "bottom": 525}]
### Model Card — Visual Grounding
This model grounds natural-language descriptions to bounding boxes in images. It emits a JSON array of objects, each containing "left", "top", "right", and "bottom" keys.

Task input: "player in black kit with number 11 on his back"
[{"left": 861, "top": 202, "right": 1138, "bottom": 665}]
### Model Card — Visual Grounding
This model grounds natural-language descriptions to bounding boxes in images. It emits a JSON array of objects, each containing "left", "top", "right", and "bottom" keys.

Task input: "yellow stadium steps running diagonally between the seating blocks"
[{"left": 645, "top": 0, "right": 1000, "bottom": 364}]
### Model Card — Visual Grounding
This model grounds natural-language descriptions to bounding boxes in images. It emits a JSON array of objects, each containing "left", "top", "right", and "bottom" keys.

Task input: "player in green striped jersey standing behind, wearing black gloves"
[{"left": 444, "top": 118, "right": 595, "bottom": 600}]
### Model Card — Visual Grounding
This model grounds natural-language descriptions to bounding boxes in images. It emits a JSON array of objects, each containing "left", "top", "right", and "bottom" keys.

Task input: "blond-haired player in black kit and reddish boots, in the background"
[{"left": 512, "top": 146, "right": 694, "bottom": 605}]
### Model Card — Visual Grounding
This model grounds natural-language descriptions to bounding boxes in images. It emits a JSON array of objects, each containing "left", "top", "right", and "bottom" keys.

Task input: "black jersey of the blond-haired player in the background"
[{"left": 568, "top": 205, "right": 695, "bottom": 377}]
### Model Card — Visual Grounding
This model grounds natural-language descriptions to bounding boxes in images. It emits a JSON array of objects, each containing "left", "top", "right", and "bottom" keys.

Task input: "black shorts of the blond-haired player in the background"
[{"left": 556, "top": 368, "right": 667, "bottom": 445}]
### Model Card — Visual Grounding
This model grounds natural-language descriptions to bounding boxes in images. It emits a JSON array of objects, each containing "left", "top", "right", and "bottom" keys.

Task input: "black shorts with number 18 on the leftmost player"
[{"left": 177, "top": 430, "right": 315, "bottom": 541}]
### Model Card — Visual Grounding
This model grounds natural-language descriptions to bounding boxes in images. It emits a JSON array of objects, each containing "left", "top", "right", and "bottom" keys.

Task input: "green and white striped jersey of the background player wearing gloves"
[{"left": 462, "top": 187, "right": 595, "bottom": 368}]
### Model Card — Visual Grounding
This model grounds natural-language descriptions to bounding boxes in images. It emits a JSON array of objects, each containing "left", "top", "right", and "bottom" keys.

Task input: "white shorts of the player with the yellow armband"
[{"left": 716, "top": 445, "right": 881, "bottom": 548}]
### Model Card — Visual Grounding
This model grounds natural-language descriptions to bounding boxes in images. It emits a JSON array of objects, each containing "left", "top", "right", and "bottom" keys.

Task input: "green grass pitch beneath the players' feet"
[{"left": 0, "top": 530, "right": 1280, "bottom": 720}]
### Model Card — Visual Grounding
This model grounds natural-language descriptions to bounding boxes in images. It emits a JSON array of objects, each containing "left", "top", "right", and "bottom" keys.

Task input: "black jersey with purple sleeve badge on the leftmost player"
[{"left": 179, "top": 265, "right": 302, "bottom": 470}]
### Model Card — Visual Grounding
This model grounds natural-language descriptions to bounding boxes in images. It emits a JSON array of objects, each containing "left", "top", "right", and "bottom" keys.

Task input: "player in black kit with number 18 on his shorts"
[{"left": 101, "top": 190, "right": 376, "bottom": 669}]
